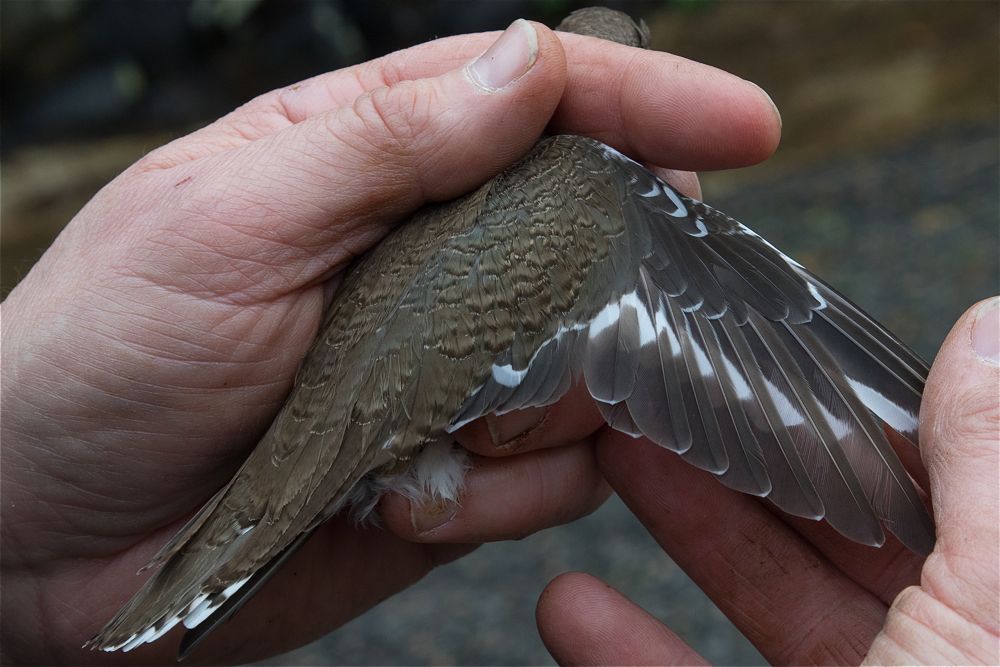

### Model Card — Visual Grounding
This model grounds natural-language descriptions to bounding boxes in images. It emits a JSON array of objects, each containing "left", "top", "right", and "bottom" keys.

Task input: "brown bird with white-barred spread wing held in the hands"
[{"left": 86, "top": 8, "right": 934, "bottom": 657}]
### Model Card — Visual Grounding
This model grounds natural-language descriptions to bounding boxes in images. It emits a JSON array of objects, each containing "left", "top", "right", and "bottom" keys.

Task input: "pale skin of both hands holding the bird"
[{"left": 0, "top": 18, "right": 1000, "bottom": 664}]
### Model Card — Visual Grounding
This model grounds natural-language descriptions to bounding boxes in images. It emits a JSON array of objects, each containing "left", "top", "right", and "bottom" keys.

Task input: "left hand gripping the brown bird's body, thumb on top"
[{"left": 2, "top": 18, "right": 779, "bottom": 663}]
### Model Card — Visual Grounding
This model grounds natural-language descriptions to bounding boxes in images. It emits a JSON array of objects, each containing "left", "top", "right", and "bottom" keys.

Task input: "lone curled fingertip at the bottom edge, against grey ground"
[{"left": 535, "top": 572, "right": 708, "bottom": 665}]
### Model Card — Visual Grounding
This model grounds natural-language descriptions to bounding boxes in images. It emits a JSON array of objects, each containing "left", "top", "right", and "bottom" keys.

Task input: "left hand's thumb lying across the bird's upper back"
[{"left": 143, "top": 19, "right": 566, "bottom": 300}]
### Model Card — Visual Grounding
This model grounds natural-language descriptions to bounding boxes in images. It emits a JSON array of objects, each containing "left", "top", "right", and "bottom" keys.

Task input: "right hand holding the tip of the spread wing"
[{"left": 538, "top": 298, "right": 1000, "bottom": 665}]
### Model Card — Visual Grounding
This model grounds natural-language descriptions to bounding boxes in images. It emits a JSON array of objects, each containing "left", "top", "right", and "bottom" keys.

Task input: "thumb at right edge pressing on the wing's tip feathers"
[{"left": 920, "top": 297, "right": 1000, "bottom": 628}]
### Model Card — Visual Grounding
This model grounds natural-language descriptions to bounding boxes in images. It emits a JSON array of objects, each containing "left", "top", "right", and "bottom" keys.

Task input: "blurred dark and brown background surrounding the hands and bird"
[{"left": 0, "top": 0, "right": 1000, "bottom": 664}]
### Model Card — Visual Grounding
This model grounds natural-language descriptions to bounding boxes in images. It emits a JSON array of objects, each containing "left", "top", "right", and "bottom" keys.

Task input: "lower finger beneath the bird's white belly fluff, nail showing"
[{"left": 379, "top": 442, "right": 610, "bottom": 543}]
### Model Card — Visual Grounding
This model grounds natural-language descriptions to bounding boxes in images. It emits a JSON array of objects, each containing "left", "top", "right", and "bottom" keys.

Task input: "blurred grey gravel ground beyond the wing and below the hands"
[{"left": 268, "top": 123, "right": 1000, "bottom": 665}]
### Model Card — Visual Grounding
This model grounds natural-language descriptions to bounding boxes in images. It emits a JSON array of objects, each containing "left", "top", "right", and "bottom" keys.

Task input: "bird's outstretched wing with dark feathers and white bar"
[{"left": 451, "top": 137, "right": 934, "bottom": 552}]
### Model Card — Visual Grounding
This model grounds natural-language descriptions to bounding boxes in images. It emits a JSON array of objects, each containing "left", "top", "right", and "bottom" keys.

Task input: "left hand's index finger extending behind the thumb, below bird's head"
[{"left": 154, "top": 32, "right": 781, "bottom": 170}]
